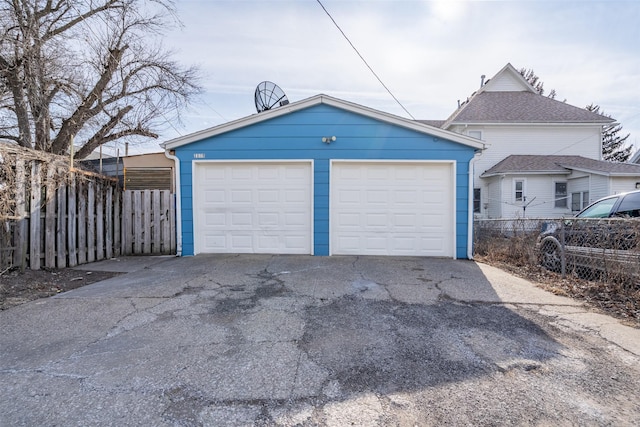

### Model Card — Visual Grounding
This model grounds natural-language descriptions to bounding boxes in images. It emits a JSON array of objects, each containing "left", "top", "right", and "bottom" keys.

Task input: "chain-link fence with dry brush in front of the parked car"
[{"left": 474, "top": 218, "right": 640, "bottom": 290}]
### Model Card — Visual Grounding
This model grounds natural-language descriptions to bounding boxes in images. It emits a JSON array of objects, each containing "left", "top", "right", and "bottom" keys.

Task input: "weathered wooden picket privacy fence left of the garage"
[{"left": 0, "top": 148, "right": 176, "bottom": 271}]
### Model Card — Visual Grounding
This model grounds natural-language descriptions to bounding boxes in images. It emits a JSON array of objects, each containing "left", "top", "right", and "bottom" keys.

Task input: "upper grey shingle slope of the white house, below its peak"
[{"left": 447, "top": 92, "right": 614, "bottom": 123}]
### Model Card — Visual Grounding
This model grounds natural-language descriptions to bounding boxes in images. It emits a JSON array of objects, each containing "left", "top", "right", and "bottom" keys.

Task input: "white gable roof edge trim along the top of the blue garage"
[{"left": 160, "top": 94, "right": 485, "bottom": 150}]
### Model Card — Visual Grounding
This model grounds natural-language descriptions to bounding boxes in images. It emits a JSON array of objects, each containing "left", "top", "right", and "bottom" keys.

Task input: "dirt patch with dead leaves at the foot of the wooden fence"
[{"left": 0, "top": 268, "right": 121, "bottom": 310}]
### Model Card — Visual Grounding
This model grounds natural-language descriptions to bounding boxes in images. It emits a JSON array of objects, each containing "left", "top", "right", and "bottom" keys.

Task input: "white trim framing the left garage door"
[{"left": 192, "top": 159, "right": 314, "bottom": 255}]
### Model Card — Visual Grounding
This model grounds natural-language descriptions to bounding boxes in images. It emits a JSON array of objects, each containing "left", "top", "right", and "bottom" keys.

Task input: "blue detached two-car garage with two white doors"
[{"left": 164, "top": 95, "right": 483, "bottom": 258}]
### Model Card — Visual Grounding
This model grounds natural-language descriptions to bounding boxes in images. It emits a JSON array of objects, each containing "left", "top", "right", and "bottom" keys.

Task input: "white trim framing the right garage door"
[{"left": 329, "top": 159, "right": 457, "bottom": 259}]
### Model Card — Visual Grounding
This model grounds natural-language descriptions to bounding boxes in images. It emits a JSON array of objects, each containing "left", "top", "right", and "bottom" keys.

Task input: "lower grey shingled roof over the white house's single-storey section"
[{"left": 480, "top": 155, "right": 640, "bottom": 178}]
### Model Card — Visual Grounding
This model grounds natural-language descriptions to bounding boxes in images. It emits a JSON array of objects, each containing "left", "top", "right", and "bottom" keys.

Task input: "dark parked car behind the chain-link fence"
[{"left": 536, "top": 191, "right": 640, "bottom": 271}]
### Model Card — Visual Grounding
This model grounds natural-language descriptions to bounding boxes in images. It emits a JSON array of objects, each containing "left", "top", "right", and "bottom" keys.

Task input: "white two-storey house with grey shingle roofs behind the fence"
[{"left": 423, "top": 64, "right": 640, "bottom": 218}]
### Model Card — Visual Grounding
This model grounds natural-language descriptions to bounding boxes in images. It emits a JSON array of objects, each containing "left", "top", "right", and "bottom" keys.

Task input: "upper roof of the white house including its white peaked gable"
[{"left": 442, "top": 64, "right": 615, "bottom": 129}]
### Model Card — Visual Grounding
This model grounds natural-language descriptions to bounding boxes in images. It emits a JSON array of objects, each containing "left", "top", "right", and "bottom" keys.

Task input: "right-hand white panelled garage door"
[{"left": 330, "top": 161, "right": 455, "bottom": 257}]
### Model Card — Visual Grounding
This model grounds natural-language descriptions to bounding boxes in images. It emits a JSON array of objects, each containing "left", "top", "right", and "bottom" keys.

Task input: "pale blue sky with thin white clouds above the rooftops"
[{"left": 130, "top": 0, "right": 640, "bottom": 154}]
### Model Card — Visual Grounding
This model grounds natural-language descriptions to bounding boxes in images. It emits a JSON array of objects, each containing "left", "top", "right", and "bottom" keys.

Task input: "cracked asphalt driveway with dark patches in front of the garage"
[{"left": 0, "top": 255, "right": 640, "bottom": 426}]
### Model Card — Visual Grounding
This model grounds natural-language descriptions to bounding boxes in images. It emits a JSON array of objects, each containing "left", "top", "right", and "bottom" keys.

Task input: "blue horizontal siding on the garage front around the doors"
[{"left": 175, "top": 104, "right": 474, "bottom": 258}]
